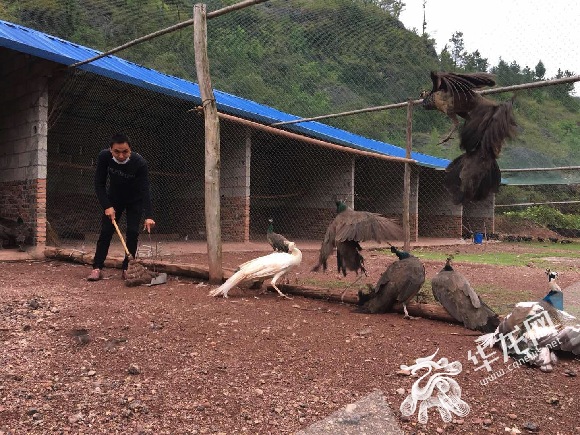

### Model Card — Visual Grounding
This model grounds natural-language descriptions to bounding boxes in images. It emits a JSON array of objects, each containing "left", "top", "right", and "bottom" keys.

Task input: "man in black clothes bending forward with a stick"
[{"left": 87, "top": 133, "right": 155, "bottom": 281}]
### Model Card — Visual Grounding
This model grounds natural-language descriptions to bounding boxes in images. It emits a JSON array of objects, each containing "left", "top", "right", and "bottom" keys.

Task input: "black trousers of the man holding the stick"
[{"left": 93, "top": 202, "right": 143, "bottom": 270}]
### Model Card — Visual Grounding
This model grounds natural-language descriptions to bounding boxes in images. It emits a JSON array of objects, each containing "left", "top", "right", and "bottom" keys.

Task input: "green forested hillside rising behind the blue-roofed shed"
[{"left": 0, "top": 0, "right": 580, "bottom": 174}]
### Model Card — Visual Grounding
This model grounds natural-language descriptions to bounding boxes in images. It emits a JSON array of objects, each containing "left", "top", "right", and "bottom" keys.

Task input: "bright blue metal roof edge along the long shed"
[{"left": 0, "top": 20, "right": 449, "bottom": 169}]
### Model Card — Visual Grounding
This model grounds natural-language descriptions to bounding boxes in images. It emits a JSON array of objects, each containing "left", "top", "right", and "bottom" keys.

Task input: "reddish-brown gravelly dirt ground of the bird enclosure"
[{"left": 0, "top": 243, "right": 580, "bottom": 435}]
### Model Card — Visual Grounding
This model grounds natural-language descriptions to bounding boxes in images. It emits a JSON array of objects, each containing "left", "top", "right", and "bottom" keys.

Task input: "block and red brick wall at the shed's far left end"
[{"left": 0, "top": 49, "right": 53, "bottom": 245}]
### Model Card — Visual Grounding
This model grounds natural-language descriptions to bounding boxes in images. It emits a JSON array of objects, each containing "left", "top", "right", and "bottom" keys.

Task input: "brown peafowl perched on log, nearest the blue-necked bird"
[{"left": 431, "top": 257, "right": 499, "bottom": 333}]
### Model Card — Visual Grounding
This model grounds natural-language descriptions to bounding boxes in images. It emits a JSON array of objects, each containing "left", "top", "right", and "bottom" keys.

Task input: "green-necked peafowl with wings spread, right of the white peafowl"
[{"left": 312, "top": 201, "right": 403, "bottom": 276}]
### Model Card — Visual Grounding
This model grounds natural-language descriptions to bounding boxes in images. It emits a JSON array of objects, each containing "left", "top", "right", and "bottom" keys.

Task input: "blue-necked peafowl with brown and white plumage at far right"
[{"left": 476, "top": 269, "right": 580, "bottom": 372}]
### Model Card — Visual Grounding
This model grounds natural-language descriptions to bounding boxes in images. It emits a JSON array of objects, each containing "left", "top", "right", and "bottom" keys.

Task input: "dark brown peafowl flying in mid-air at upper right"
[{"left": 421, "top": 71, "right": 516, "bottom": 204}]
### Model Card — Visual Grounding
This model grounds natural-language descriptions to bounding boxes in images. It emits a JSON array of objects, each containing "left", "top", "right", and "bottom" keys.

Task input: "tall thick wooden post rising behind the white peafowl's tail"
[{"left": 193, "top": 3, "right": 223, "bottom": 284}]
